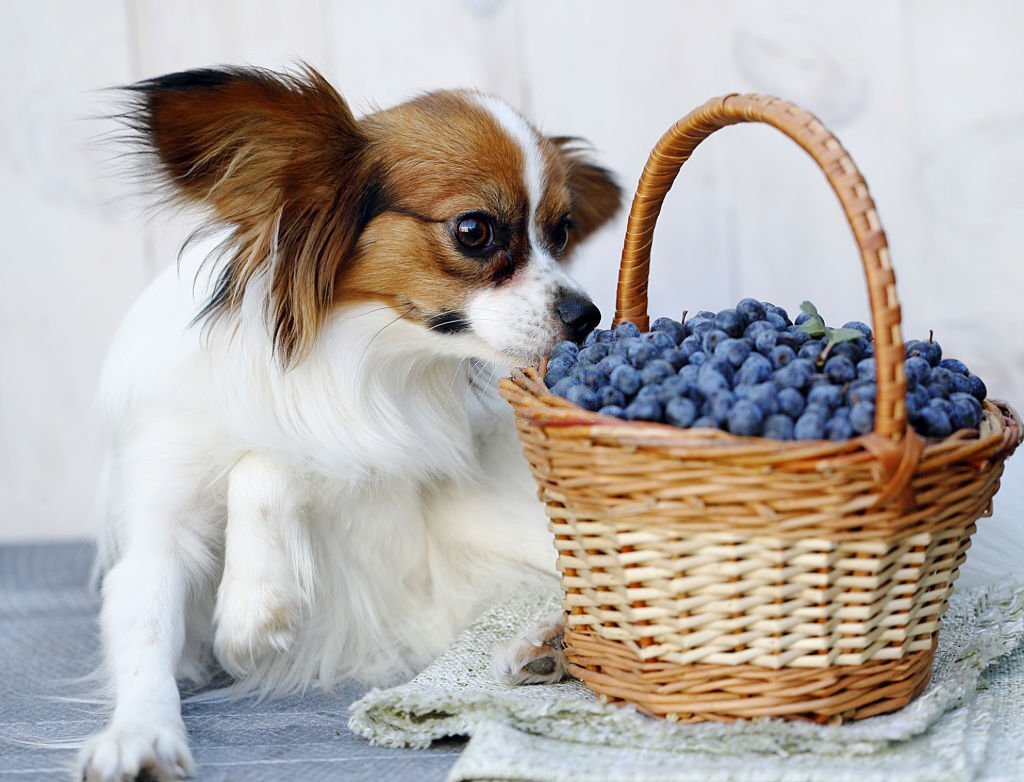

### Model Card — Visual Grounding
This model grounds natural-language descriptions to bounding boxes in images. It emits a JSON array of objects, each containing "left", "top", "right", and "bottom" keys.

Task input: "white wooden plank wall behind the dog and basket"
[{"left": 0, "top": 0, "right": 1024, "bottom": 539}]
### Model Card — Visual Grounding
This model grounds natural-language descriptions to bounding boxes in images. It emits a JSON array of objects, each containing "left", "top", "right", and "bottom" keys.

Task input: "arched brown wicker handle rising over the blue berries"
[{"left": 613, "top": 94, "right": 906, "bottom": 440}]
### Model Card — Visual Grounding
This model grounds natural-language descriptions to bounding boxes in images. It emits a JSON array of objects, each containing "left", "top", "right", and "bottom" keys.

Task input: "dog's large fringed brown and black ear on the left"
[{"left": 123, "top": 68, "right": 382, "bottom": 365}]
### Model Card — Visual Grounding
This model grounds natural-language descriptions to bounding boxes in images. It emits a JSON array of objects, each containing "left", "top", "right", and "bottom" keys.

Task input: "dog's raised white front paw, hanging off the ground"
[{"left": 213, "top": 575, "right": 302, "bottom": 678}]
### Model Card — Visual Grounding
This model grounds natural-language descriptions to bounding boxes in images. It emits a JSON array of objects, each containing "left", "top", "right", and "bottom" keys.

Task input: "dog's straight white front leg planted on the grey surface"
[{"left": 80, "top": 527, "right": 193, "bottom": 782}]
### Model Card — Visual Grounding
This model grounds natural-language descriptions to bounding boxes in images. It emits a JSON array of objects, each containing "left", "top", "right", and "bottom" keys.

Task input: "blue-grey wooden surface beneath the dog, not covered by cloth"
[{"left": 0, "top": 542, "right": 463, "bottom": 782}]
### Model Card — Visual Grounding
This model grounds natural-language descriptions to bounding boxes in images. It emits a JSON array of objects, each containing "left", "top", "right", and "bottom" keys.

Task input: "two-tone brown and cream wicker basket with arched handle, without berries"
[{"left": 502, "top": 95, "right": 1021, "bottom": 722}]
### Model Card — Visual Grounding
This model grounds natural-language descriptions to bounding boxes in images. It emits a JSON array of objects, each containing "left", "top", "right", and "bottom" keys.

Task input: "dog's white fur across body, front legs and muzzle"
[{"left": 83, "top": 94, "right": 579, "bottom": 779}]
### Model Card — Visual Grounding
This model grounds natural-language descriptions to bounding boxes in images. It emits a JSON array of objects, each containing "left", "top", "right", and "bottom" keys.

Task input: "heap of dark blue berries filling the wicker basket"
[{"left": 544, "top": 299, "right": 986, "bottom": 440}]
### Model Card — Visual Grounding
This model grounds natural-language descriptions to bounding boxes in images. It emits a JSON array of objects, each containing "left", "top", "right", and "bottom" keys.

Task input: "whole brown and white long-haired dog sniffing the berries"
[{"left": 80, "top": 67, "right": 621, "bottom": 781}]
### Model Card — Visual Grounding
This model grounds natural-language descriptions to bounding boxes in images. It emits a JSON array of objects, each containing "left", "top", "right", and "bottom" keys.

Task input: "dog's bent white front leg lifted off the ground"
[{"left": 214, "top": 452, "right": 315, "bottom": 677}]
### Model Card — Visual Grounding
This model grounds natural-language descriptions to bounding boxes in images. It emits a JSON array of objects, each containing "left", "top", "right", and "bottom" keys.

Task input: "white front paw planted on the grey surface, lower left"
[{"left": 79, "top": 720, "right": 196, "bottom": 782}]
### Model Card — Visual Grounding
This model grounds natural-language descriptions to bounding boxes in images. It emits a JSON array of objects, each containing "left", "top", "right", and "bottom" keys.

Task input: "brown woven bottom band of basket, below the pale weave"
[{"left": 564, "top": 627, "right": 938, "bottom": 724}]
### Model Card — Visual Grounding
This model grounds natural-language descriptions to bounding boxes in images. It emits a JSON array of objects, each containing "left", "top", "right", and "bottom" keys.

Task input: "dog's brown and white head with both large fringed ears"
[{"left": 126, "top": 69, "right": 620, "bottom": 365}]
